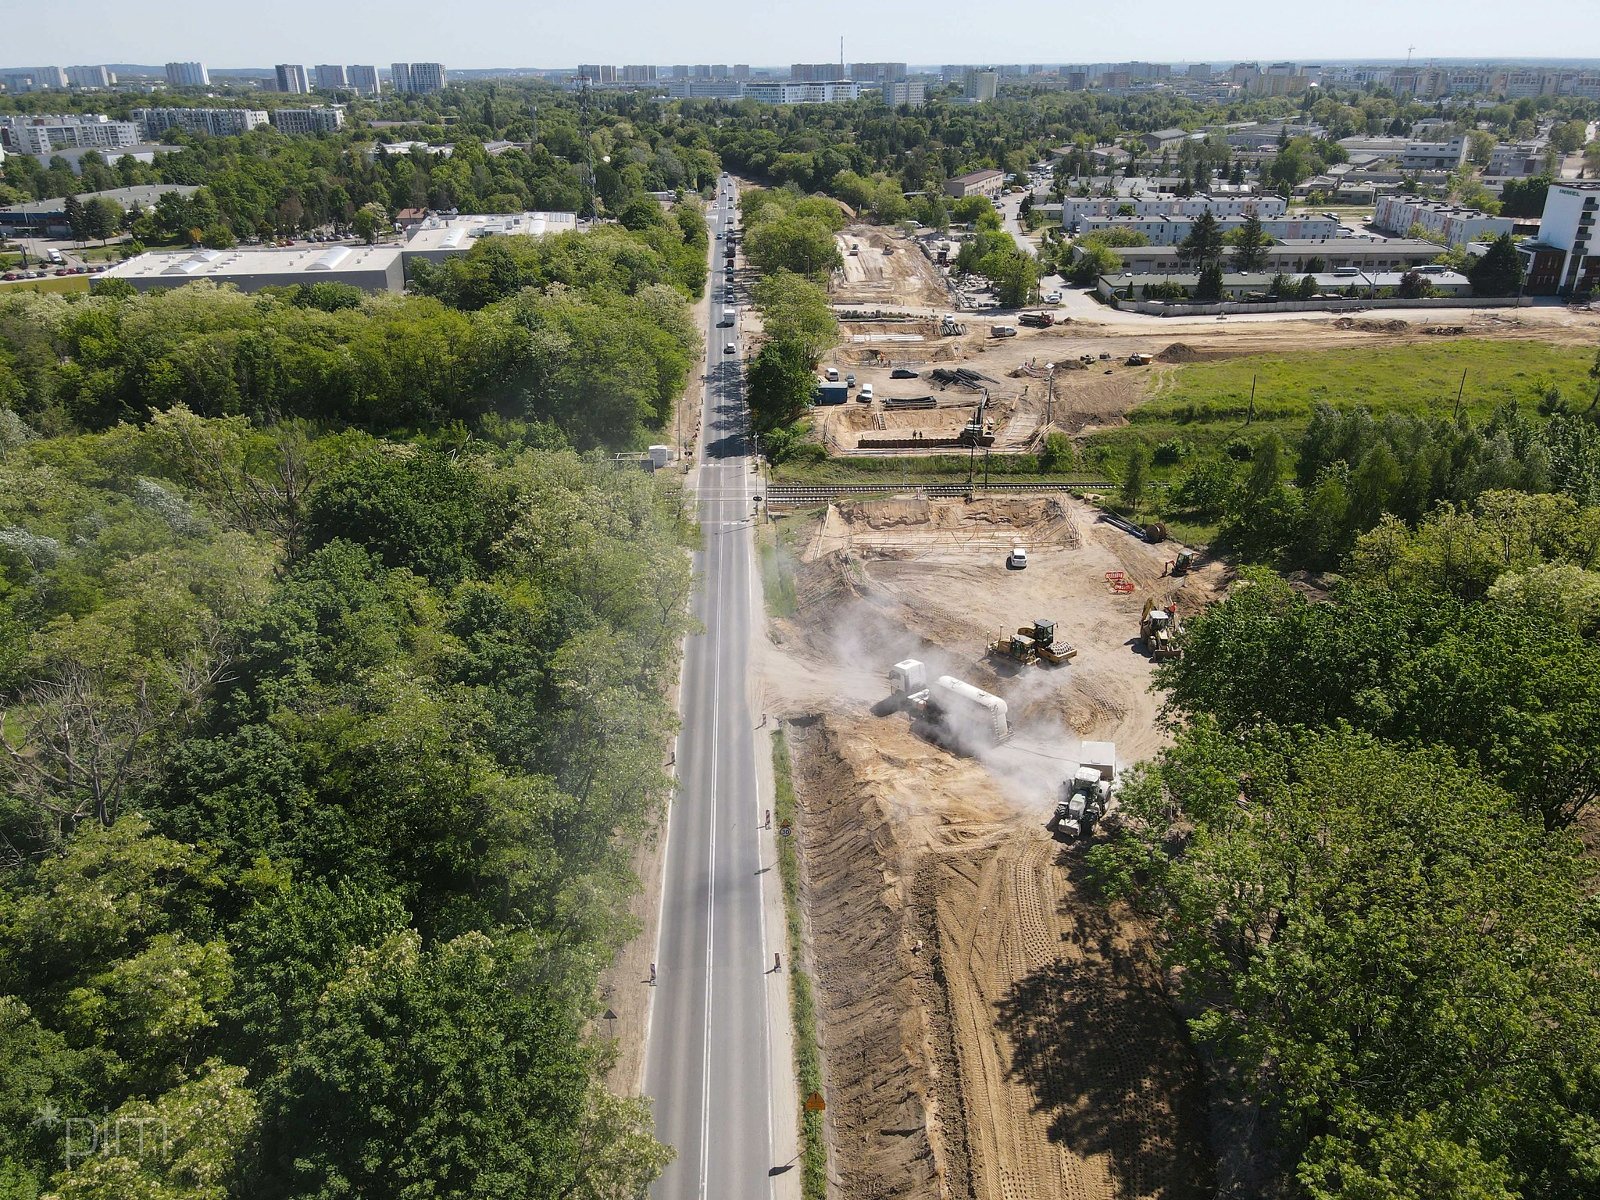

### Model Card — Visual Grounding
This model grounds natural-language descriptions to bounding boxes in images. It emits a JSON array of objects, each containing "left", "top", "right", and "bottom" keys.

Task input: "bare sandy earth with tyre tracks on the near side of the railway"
[{"left": 762, "top": 498, "right": 1222, "bottom": 1200}]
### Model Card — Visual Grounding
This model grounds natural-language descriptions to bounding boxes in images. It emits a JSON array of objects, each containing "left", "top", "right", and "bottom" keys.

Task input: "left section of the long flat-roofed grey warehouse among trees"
[{"left": 101, "top": 245, "right": 405, "bottom": 291}]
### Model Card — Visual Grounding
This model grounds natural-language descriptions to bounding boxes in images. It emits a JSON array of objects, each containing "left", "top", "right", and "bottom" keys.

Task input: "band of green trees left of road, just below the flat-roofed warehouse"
[{"left": 0, "top": 209, "right": 706, "bottom": 450}]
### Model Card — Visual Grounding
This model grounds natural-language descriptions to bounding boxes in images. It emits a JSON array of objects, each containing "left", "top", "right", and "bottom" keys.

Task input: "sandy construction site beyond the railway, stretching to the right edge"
[{"left": 811, "top": 226, "right": 1597, "bottom": 458}]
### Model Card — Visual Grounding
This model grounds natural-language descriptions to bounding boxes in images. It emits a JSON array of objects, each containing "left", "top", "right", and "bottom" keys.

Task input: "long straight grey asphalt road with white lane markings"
[{"left": 645, "top": 184, "right": 787, "bottom": 1200}]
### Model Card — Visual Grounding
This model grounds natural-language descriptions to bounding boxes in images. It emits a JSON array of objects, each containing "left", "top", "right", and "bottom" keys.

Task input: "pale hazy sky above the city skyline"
[{"left": 12, "top": 0, "right": 1600, "bottom": 67}]
